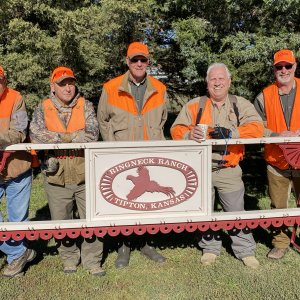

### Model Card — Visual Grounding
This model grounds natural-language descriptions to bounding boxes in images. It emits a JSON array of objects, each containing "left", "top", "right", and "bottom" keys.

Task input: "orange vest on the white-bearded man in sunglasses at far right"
[{"left": 263, "top": 78, "right": 300, "bottom": 170}]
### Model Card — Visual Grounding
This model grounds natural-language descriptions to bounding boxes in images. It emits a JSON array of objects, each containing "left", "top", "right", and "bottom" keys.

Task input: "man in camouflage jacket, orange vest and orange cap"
[{"left": 30, "top": 67, "right": 105, "bottom": 276}]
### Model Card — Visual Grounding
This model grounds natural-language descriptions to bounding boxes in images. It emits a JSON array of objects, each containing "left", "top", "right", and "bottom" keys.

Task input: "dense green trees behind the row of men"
[{"left": 0, "top": 0, "right": 300, "bottom": 112}]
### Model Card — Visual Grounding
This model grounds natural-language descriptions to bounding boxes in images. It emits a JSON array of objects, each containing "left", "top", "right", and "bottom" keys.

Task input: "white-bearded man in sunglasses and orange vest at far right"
[{"left": 254, "top": 49, "right": 300, "bottom": 259}]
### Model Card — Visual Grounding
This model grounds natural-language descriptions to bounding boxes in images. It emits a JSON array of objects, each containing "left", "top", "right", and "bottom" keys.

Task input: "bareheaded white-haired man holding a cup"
[{"left": 171, "top": 63, "right": 263, "bottom": 269}]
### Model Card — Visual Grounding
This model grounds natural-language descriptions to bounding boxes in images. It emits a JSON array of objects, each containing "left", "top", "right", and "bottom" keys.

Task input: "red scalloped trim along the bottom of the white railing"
[{"left": 0, "top": 216, "right": 300, "bottom": 250}]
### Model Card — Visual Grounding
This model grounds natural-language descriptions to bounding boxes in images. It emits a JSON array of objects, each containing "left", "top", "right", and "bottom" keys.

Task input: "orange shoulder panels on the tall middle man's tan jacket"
[{"left": 104, "top": 75, "right": 166, "bottom": 140}]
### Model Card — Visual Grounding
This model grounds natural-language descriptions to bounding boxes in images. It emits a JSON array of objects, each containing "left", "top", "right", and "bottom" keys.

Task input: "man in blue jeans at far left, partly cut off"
[{"left": 0, "top": 66, "right": 36, "bottom": 277}]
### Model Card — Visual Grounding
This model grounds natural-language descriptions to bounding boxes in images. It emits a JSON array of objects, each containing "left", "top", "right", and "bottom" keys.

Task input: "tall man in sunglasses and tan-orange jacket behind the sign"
[{"left": 97, "top": 42, "right": 168, "bottom": 268}]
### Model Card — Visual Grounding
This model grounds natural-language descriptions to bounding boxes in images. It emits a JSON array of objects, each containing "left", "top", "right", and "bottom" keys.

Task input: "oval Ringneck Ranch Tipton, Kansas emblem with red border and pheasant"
[{"left": 98, "top": 156, "right": 200, "bottom": 211}]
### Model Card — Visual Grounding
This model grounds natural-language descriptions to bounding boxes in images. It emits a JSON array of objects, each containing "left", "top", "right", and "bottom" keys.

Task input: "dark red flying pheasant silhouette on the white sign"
[{"left": 126, "top": 166, "right": 175, "bottom": 200}]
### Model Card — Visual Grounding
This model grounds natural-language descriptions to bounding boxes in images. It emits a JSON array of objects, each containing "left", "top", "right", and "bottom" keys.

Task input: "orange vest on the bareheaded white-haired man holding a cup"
[{"left": 200, "top": 101, "right": 245, "bottom": 167}]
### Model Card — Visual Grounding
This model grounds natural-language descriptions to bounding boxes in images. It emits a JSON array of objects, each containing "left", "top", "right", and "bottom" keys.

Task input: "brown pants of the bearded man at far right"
[{"left": 267, "top": 166, "right": 300, "bottom": 249}]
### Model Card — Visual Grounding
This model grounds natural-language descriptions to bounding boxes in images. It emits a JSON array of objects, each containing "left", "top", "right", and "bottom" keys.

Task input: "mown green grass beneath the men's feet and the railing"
[{"left": 0, "top": 169, "right": 300, "bottom": 300}]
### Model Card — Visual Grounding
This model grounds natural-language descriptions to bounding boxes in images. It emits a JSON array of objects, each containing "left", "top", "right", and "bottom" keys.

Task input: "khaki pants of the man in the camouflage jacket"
[{"left": 44, "top": 180, "right": 103, "bottom": 270}]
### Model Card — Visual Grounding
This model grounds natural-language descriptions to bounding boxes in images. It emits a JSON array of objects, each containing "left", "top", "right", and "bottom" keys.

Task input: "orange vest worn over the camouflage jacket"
[{"left": 43, "top": 97, "right": 85, "bottom": 133}]
